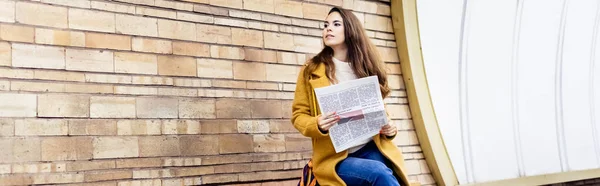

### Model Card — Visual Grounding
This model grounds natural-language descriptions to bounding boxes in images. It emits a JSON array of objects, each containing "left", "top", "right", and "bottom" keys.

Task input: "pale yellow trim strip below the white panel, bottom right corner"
[{"left": 460, "top": 169, "right": 600, "bottom": 186}]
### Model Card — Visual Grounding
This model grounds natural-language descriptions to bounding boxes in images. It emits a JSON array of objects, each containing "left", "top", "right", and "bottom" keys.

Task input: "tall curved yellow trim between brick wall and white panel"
[{"left": 391, "top": 0, "right": 458, "bottom": 186}]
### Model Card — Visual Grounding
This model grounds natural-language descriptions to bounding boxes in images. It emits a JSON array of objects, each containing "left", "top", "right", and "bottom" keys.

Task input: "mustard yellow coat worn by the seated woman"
[{"left": 291, "top": 63, "right": 409, "bottom": 186}]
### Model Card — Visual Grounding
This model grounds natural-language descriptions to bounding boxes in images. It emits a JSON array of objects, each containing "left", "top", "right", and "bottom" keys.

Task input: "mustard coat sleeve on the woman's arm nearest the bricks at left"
[{"left": 291, "top": 67, "right": 329, "bottom": 138}]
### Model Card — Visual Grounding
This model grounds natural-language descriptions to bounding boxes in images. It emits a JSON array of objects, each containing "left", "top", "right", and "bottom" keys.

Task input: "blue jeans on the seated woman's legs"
[{"left": 335, "top": 141, "right": 400, "bottom": 186}]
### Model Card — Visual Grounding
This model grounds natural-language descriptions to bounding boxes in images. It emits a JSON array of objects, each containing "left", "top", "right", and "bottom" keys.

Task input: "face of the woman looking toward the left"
[{"left": 323, "top": 12, "right": 346, "bottom": 47}]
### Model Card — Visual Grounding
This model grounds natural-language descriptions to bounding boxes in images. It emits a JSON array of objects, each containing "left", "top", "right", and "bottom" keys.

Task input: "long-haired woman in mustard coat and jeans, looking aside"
[{"left": 291, "top": 7, "right": 408, "bottom": 186}]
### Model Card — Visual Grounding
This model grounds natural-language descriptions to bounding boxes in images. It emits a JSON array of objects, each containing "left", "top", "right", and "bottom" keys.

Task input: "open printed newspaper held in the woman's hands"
[{"left": 315, "top": 76, "right": 387, "bottom": 153}]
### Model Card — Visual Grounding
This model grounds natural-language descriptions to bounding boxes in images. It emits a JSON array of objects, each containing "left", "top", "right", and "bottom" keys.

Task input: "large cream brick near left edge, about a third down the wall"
[{"left": 12, "top": 43, "right": 65, "bottom": 69}]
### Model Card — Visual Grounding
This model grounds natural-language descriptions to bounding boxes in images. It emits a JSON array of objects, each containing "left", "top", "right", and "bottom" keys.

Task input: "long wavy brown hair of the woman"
[{"left": 304, "top": 7, "right": 390, "bottom": 98}]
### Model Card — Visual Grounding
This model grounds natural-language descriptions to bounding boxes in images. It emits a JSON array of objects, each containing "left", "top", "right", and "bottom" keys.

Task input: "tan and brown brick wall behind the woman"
[{"left": 0, "top": 0, "right": 433, "bottom": 186}]
